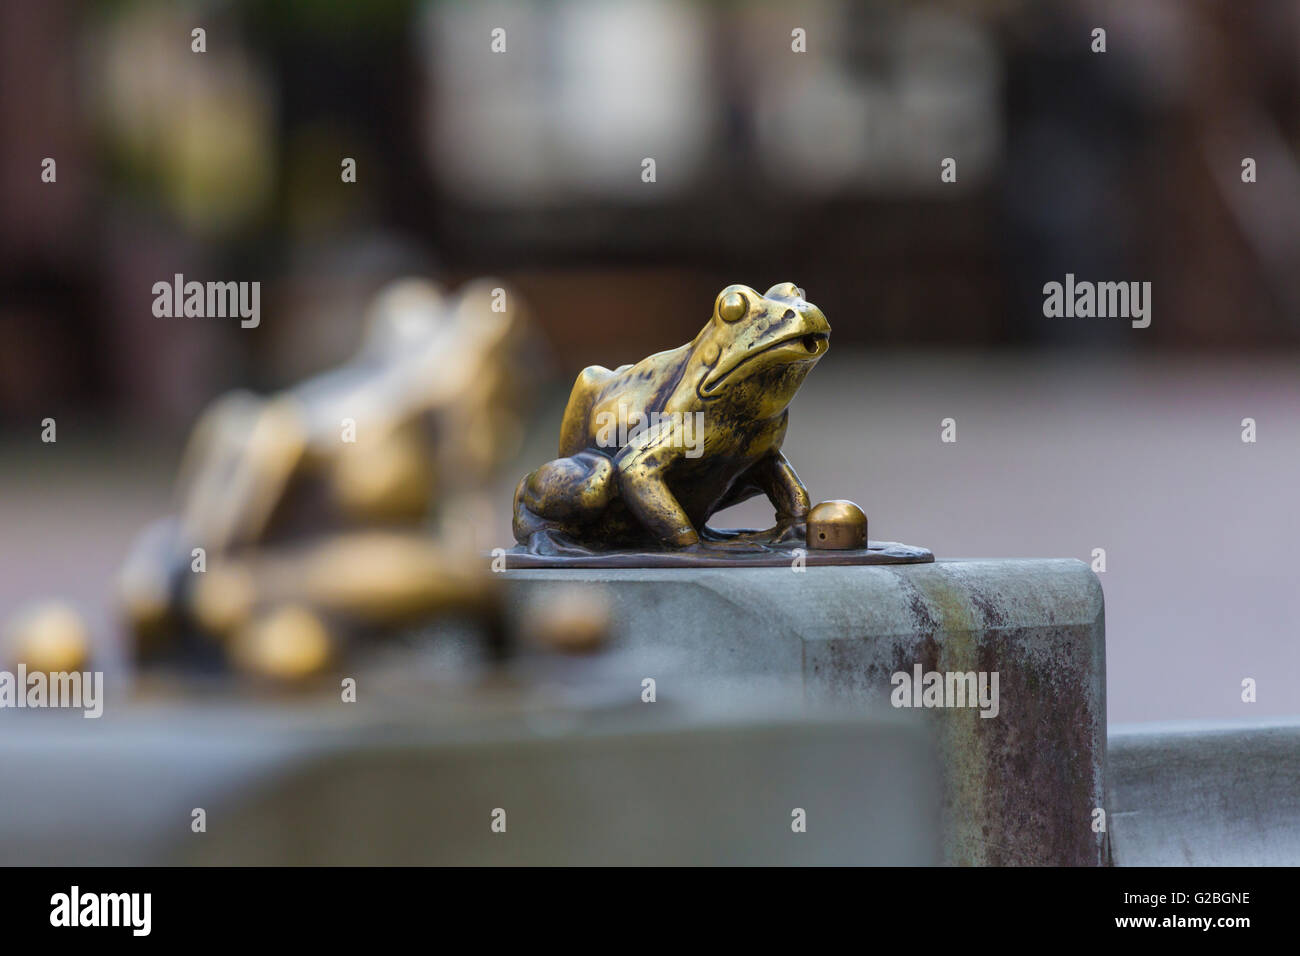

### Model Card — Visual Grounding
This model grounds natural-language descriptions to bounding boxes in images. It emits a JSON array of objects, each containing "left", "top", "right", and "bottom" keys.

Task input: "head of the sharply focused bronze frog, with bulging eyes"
[{"left": 694, "top": 282, "right": 831, "bottom": 415}]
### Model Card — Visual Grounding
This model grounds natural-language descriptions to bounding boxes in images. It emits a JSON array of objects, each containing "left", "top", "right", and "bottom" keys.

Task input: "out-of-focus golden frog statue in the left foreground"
[{"left": 118, "top": 280, "right": 529, "bottom": 679}]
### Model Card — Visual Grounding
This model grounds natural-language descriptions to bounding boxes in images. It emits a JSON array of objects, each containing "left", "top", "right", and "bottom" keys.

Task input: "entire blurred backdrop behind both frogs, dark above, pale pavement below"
[{"left": 0, "top": 0, "right": 1300, "bottom": 719}]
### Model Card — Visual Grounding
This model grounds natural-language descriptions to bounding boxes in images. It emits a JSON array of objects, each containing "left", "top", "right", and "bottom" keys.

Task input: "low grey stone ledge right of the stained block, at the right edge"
[{"left": 1108, "top": 718, "right": 1300, "bottom": 866}]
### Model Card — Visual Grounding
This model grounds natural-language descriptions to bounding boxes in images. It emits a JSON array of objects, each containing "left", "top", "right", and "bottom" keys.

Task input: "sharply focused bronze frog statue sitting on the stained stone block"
[{"left": 514, "top": 282, "right": 831, "bottom": 555}]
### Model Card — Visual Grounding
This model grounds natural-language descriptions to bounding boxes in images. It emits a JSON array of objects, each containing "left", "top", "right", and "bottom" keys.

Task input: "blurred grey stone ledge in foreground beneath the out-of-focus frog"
[{"left": 0, "top": 691, "right": 939, "bottom": 866}]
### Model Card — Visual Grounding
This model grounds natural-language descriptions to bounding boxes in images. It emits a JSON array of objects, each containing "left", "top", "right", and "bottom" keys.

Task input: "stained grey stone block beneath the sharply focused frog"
[{"left": 506, "top": 559, "right": 1106, "bottom": 865}]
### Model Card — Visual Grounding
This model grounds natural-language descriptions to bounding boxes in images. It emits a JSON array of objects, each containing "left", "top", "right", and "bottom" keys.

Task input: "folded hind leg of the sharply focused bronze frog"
[{"left": 514, "top": 451, "right": 618, "bottom": 554}]
